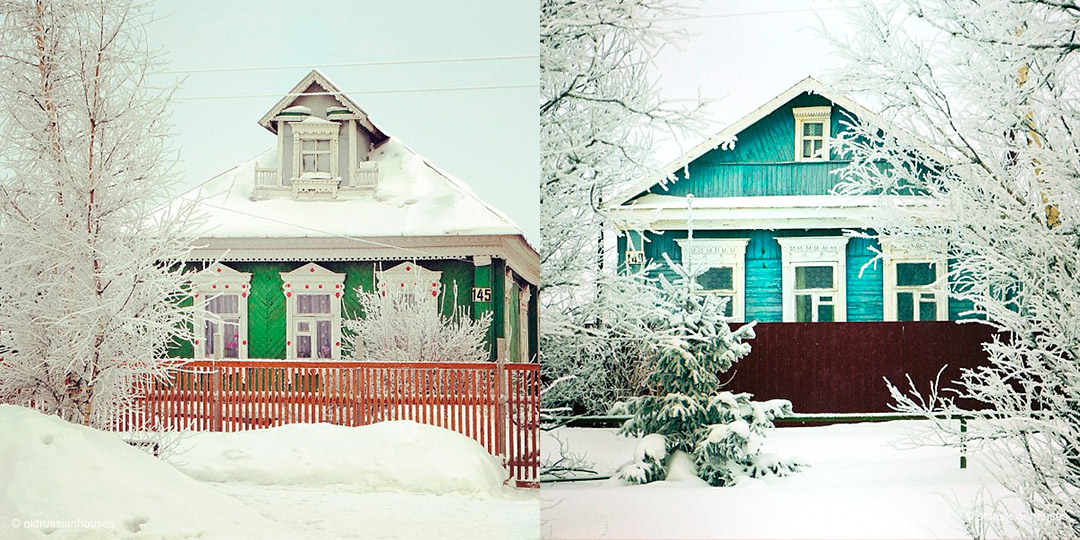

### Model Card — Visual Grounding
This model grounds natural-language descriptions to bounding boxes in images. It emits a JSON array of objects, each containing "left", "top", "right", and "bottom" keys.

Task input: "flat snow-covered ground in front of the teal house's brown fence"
[{"left": 540, "top": 421, "right": 1004, "bottom": 539}]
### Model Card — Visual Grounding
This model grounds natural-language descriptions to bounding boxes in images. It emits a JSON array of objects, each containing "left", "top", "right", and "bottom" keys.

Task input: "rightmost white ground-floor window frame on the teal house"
[{"left": 881, "top": 240, "right": 948, "bottom": 321}]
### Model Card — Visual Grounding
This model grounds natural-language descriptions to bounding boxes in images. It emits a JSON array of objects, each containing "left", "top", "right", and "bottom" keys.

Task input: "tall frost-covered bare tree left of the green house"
[{"left": 0, "top": 0, "right": 200, "bottom": 424}]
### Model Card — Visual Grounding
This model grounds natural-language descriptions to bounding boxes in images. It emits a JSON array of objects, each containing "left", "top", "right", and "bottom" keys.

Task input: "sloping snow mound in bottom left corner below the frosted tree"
[{"left": 0, "top": 405, "right": 297, "bottom": 540}]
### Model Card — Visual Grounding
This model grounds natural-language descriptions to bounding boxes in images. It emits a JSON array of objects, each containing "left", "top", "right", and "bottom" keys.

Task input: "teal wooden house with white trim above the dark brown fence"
[{"left": 612, "top": 78, "right": 964, "bottom": 322}]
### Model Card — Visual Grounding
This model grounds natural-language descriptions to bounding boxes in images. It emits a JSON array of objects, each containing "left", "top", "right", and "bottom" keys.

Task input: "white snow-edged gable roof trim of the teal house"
[{"left": 609, "top": 77, "right": 946, "bottom": 207}]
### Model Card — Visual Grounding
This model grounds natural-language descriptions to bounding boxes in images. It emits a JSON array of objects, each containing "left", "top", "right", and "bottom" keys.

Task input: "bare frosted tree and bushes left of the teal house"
[{"left": 539, "top": 0, "right": 699, "bottom": 413}]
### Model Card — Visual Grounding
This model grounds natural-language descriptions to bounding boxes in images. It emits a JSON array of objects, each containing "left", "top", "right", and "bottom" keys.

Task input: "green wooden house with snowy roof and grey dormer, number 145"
[{"left": 175, "top": 70, "right": 540, "bottom": 362}]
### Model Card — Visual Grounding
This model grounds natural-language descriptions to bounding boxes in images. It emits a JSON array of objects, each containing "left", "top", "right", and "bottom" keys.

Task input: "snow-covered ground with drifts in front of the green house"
[{"left": 0, "top": 405, "right": 540, "bottom": 540}]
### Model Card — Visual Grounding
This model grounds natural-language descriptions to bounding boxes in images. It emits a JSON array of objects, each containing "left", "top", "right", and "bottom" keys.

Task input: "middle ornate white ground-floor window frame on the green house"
[{"left": 281, "top": 262, "right": 345, "bottom": 362}]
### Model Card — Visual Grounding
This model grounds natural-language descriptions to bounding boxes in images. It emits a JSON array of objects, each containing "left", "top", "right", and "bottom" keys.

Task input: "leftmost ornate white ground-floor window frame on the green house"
[{"left": 191, "top": 262, "right": 252, "bottom": 360}]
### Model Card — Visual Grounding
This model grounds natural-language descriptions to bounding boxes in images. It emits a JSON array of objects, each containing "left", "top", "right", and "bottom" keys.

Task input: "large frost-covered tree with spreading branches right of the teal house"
[{"left": 839, "top": 0, "right": 1080, "bottom": 538}]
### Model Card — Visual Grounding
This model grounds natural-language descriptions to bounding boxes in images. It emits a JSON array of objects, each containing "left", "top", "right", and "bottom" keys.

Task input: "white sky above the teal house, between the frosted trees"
[{"left": 657, "top": 0, "right": 848, "bottom": 165}]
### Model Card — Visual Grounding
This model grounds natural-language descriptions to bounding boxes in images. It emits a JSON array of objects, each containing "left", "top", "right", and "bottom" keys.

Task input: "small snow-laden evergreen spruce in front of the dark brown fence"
[{"left": 618, "top": 254, "right": 798, "bottom": 486}]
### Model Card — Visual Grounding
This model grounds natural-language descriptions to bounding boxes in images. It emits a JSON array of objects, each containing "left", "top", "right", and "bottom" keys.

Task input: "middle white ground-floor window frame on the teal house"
[{"left": 777, "top": 237, "right": 848, "bottom": 323}]
